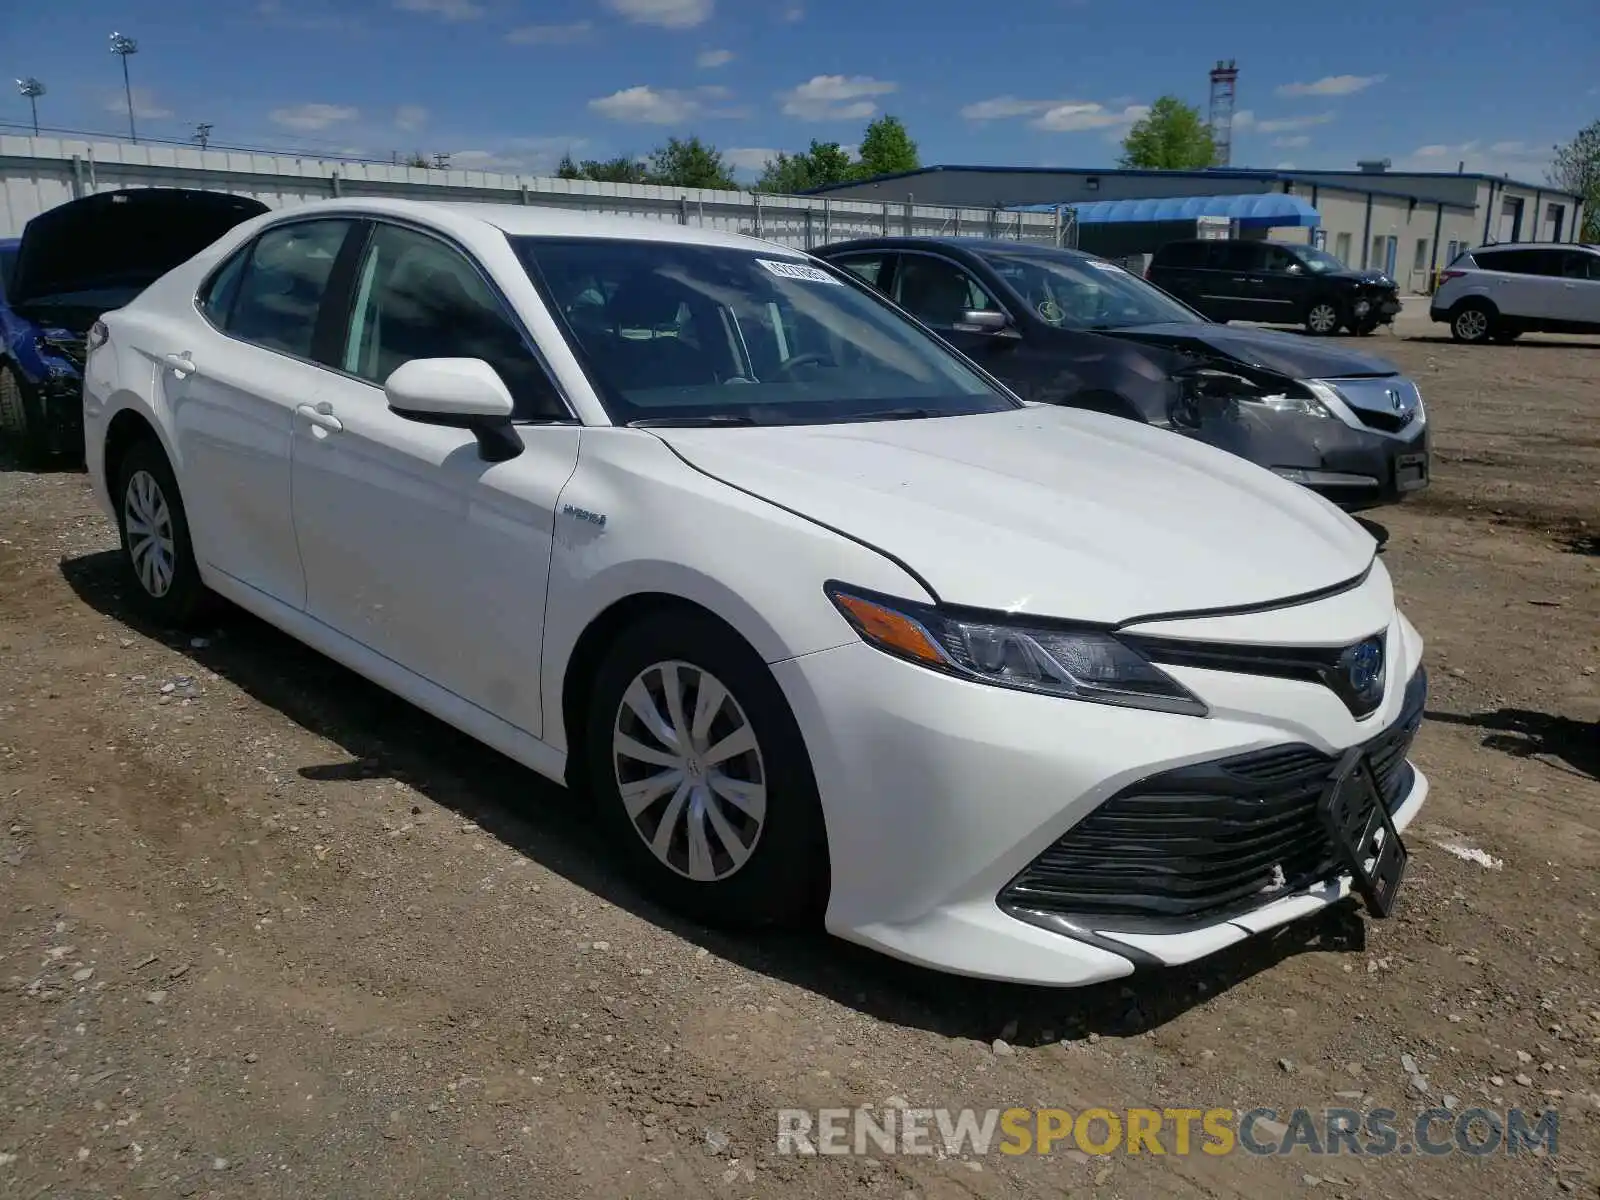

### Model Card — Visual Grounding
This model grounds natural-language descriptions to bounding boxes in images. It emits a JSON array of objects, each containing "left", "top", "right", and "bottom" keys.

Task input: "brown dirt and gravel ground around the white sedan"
[{"left": 0, "top": 334, "right": 1600, "bottom": 1200}]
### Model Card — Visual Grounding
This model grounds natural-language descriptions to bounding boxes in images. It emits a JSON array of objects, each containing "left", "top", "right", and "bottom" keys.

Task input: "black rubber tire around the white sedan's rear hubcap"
[{"left": 110, "top": 438, "right": 211, "bottom": 629}]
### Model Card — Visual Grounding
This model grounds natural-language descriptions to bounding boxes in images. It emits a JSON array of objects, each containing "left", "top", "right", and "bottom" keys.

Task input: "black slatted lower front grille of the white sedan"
[{"left": 998, "top": 669, "right": 1427, "bottom": 933}]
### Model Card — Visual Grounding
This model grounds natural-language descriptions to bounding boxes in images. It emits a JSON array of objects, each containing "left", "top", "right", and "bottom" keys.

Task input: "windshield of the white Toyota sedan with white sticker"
[{"left": 510, "top": 237, "right": 1016, "bottom": 424}]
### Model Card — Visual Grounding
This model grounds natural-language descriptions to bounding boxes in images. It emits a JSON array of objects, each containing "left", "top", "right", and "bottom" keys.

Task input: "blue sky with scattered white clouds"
[{"left": 0, "top": 0, "right": 1600, "bottom": 179}]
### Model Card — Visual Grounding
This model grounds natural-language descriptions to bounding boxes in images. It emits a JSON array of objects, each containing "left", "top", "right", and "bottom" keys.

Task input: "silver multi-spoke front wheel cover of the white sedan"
[{"left": 611, "top": 661, "right": 766, "bottom": 883}]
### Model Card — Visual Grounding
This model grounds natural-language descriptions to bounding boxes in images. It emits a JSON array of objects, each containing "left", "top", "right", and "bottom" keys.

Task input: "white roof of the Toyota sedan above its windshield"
[{"left": 254, "top": 197, "right": 802, "bottom": 256}]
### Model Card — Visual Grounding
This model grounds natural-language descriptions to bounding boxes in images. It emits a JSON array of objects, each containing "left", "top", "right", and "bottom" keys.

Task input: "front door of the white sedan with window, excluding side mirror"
[{"left": 293, "top": 222, "right": 579, "bottom": 738}]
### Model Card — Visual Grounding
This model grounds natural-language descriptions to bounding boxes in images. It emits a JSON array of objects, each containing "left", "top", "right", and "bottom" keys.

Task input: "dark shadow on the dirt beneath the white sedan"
[{"left": 61, "top": 550, "right": 1365, "bottom": 1046}]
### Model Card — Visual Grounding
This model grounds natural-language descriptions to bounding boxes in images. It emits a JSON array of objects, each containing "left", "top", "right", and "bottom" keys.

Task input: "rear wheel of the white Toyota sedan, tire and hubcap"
[{"left": 112, "top": 438, "right": 210, "bottom": 629}]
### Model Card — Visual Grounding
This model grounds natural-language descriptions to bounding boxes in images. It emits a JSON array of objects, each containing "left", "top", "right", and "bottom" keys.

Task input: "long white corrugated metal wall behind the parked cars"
[{"left": 0, "top": 136, "right": 1061, "bottom": 248}]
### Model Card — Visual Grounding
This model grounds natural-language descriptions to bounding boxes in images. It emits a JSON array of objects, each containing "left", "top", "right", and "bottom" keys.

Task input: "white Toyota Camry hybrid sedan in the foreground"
[{"left": 83, "top": 200, "right": 1427, "bottom": 984}]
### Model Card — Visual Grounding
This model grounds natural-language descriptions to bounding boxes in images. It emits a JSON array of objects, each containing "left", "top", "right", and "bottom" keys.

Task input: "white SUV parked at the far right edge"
[{"left": 1427, "top": 243, "right": 1600, "bottom": 342}]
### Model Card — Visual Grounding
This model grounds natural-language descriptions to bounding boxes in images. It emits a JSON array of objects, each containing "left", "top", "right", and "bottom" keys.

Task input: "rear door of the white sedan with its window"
[{"left": 155, "top": 219, "right": 355, "bottom": 608}]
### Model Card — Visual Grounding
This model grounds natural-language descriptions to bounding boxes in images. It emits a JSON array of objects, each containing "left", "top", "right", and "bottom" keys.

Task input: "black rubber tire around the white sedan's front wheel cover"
[{"left": 582, "top": 611, "right": 829, "bottom": 928}]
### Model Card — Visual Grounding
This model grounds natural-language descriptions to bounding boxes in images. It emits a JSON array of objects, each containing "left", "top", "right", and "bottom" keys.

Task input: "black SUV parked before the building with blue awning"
[{"left": 1144, "top": 238, "right": 1400, "bottom": 336}]
